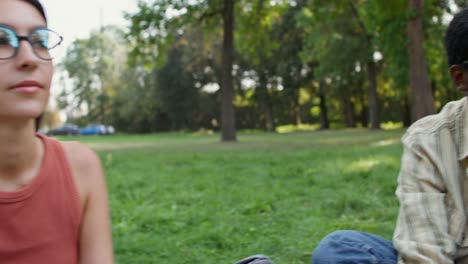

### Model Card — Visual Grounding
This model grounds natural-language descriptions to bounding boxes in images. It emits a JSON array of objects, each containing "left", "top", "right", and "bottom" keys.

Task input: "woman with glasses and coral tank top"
[{"left": 0, "top": 0, "right": 113, "bottom": 264}]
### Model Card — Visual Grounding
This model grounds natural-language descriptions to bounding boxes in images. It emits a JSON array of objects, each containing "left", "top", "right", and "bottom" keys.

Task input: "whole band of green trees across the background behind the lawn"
[{"left": 57, "top": 0, "right": 466, "bottom": 134}]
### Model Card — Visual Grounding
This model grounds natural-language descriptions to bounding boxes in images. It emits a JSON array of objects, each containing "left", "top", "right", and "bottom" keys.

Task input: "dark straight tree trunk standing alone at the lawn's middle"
[{"left": 221, "top": 0, "right": 236, "bottom": 141}]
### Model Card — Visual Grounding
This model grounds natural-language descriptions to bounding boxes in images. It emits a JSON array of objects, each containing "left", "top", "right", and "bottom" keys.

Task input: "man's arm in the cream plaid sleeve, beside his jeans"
[{"left": 393, "top": 139, "right": 456, "bottom": 264}]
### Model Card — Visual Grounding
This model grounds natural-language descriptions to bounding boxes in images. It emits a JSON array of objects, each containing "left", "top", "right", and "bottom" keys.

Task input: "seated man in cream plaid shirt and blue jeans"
[{"left": 312, "top": 9, "right": 468, "bottom": 264}]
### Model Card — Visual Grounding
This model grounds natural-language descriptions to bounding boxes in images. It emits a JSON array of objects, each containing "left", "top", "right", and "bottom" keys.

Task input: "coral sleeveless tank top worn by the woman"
[{"left": 0, "top": 134, "right": 81, "bottom": 264}]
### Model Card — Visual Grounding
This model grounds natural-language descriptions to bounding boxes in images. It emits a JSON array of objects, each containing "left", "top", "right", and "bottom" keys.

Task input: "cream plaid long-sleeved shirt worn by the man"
[{"left": 393, "top": 98, "right": 468, "bottom": 264}]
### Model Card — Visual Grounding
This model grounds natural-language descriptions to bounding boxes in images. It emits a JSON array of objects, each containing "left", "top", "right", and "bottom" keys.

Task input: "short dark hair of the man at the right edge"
[{"left": 445, "top": 8, "right": 468, "bottom": 66}]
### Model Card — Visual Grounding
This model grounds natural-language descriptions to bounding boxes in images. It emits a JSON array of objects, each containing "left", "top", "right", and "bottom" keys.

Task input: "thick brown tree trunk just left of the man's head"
[{"left": 406, "top": 0, "right": 435, "bottom": 122}]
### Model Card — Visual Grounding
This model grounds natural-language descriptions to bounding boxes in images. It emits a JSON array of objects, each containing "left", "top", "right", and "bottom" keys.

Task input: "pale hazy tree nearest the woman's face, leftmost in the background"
[{"left": 58, "top": 27, "right": 126, "bottom": 123}]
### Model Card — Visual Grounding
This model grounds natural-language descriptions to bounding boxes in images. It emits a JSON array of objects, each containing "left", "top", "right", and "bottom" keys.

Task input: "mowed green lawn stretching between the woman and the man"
[{"left": 62, "top": 130, "right": 404, "bottom": 264}]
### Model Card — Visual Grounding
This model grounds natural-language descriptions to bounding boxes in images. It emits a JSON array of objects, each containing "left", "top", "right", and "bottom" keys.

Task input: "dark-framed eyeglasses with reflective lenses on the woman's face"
[{"left": 0, "top": 25, "right": 63, "bottom": 60}]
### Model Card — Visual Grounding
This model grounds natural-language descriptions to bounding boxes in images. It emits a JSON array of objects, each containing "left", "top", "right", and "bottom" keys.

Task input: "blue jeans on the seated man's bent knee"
[{"left": 312, "top": 230, "right": 398, "bottom": 264}]
